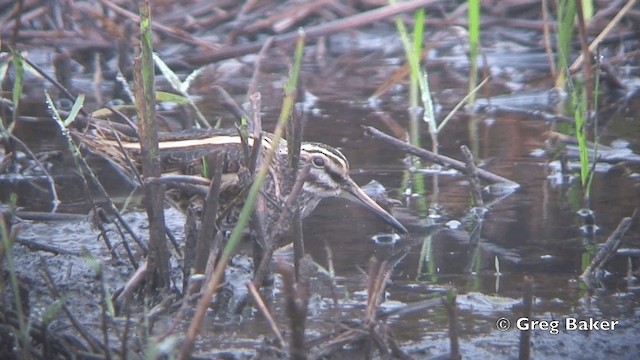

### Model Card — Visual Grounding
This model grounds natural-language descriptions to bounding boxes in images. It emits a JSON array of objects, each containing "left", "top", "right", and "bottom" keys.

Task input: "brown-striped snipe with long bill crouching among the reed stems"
[{"left": 76, "top": 130, "right": 407, "bottom": 233}]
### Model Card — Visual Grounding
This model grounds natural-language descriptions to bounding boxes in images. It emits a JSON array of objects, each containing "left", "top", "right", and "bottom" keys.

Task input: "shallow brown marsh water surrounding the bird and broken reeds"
[{"left": 2, "top": 21, "right": 640, "bottom": 359}]
